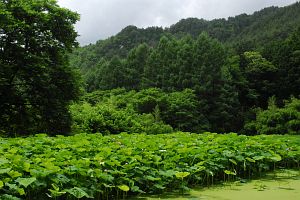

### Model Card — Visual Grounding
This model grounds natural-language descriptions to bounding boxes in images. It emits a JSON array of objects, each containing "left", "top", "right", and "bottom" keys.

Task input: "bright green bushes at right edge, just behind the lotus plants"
[{"left": 244, "top": 98, "right": 300, "bottom": 134}]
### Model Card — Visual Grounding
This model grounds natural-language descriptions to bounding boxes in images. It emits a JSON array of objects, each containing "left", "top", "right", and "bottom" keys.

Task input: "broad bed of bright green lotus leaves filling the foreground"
[{"left": 0, "top": 132, "right": 300, "bottom": 200}]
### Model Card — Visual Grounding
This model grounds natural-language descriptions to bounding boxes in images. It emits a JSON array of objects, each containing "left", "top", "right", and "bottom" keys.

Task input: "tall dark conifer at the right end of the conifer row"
[{"left": 193, "top": 33, "right": 238, "bottom": 132}]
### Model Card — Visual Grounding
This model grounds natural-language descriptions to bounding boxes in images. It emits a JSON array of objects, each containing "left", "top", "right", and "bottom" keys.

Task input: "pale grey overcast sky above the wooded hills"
[{"left": 58, "top": 0, "right": 297, "bottom": 45}]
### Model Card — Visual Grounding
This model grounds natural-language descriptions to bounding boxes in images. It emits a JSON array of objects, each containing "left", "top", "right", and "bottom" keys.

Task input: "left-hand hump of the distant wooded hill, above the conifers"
[{"left": 70, "top": 26, "right": 164, "bottom": 73}]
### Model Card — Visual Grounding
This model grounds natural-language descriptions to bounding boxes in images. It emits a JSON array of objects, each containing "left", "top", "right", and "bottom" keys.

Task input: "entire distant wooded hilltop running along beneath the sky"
[{"left": 71, "top": 2, "right": 300, "bottom": 70}]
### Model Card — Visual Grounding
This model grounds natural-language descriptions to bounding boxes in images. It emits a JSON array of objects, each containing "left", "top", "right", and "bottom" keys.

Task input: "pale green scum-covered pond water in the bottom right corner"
[{"left": 128, "top": 170, "right": 300, "bottom": 200}]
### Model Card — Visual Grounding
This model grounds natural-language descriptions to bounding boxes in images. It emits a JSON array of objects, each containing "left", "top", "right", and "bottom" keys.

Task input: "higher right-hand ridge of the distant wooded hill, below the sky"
[{"left": 167, "top": 2, "right": 300, "bottom": 48}]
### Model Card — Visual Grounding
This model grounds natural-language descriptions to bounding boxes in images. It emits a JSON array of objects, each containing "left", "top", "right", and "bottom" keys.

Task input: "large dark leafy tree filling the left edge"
[{"left": 0, "top": 0, "right": 79, "bottom": 136}]
